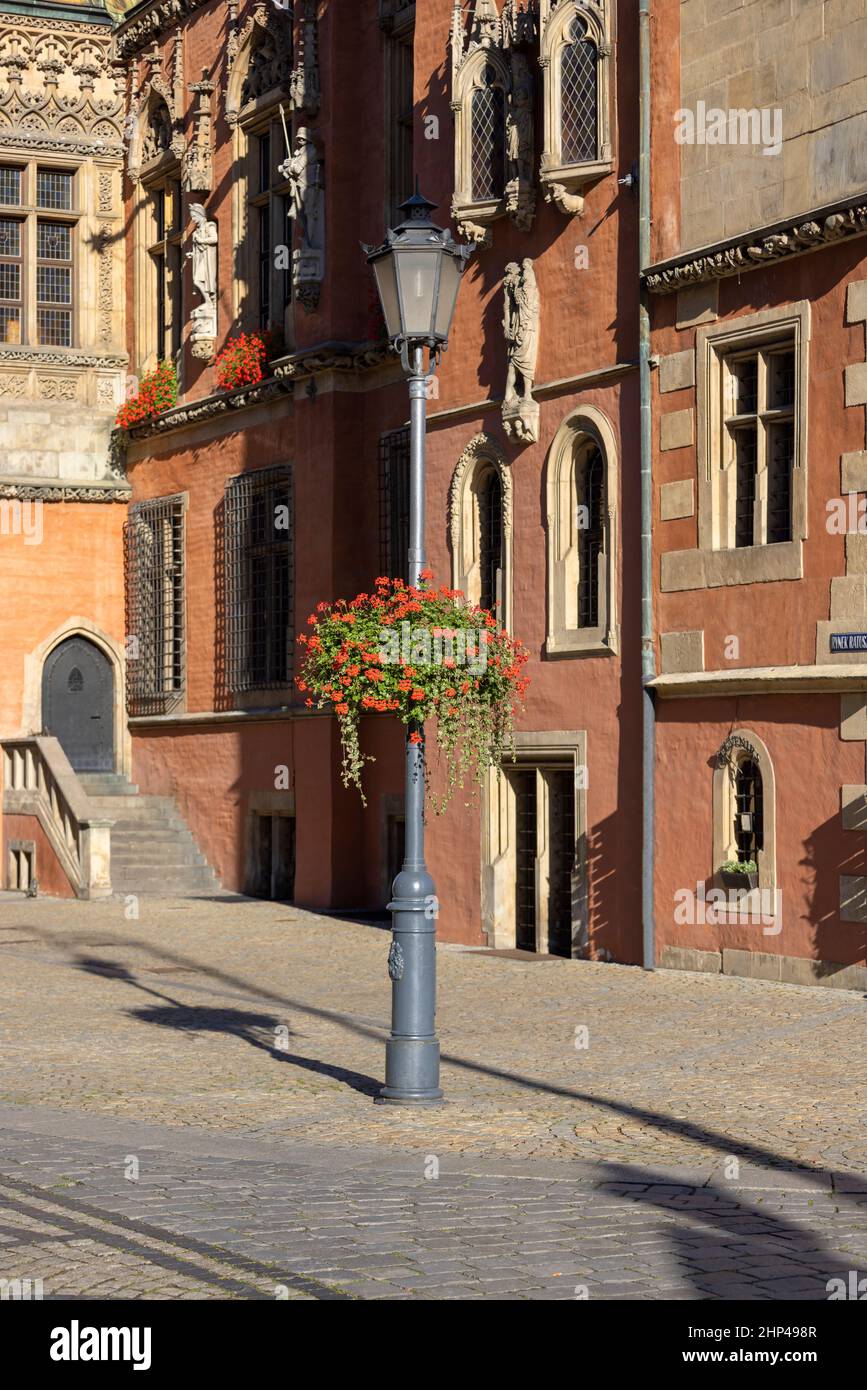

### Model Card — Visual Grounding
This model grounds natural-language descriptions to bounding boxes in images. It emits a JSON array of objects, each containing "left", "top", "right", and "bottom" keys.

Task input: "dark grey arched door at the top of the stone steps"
[{"left": 42, "top": 637, "right": 114, "bottom": 773}]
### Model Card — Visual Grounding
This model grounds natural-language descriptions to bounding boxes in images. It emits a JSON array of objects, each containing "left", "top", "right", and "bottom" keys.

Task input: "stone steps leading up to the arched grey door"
[{"left": 78, "top": 773, "right": 221, "bottom": 898}]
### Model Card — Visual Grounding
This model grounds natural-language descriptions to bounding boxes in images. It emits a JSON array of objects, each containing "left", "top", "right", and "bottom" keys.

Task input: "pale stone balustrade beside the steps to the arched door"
[{"left": 1, "top": 735, "right": 114, "bottom": 898}]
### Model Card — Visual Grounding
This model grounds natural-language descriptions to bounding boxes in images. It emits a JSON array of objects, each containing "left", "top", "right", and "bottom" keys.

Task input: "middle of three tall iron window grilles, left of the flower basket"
[{"left": 225, "top": 467, "right": 293, "bottom": 691}]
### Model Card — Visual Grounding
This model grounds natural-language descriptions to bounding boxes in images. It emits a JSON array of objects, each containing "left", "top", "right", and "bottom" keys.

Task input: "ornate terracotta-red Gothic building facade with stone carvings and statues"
[{"left": 0, "top": 0, "right": 867, "bottom": 984}]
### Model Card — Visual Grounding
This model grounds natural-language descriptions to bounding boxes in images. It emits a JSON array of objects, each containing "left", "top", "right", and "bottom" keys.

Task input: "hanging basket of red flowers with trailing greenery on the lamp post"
[{"left": 296, "top": 570, "right": 528, "bottom": 812}]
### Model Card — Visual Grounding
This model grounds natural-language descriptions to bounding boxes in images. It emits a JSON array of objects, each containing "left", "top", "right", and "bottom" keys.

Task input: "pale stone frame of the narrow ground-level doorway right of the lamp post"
[{"left": 481, "top": 730, "right": 589, "bottom": 959}]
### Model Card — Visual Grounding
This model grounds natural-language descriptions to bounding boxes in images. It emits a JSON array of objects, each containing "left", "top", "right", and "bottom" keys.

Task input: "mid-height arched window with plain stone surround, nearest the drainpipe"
[{"left": 546, "top": 406, "right": 618, "bottom": 656}]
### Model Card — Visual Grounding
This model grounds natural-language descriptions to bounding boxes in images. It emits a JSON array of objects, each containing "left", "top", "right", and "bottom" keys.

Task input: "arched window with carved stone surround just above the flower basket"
[{"left": 449, "top": 434, "right": 511, "bottom": 630}]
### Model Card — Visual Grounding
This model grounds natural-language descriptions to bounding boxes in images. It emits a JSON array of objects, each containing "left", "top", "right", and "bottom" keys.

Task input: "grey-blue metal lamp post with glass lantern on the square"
[{"left": 365, "top": 193, "right": 472, "bottom": 1105}]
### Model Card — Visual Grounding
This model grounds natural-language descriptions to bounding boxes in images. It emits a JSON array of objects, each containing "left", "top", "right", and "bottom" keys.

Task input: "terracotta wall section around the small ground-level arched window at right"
[{"left": 656, "top": 694, "right": 867, "bottom": 965}]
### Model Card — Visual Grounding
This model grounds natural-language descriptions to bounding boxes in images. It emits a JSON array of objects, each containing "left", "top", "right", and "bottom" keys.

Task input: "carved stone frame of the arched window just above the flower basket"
[{"left": 449, "top": 434, "right": 514, "bottom": 632}]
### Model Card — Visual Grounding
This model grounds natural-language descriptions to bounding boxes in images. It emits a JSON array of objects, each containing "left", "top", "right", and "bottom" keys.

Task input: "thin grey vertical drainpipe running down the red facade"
[{"left": 638, "top": 0, "right": 656, "bottom": 970}]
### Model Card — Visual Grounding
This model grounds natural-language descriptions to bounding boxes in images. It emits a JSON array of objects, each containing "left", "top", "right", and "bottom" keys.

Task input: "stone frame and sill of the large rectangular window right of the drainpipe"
[{"left": 661, "top": 299, "right": 810, "bottom": 592}]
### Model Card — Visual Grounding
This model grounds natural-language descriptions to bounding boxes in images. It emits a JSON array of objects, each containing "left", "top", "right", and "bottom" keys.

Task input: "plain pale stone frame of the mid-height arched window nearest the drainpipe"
[{"left": 545, "top": 404, "right": 620, "bottom": 656}]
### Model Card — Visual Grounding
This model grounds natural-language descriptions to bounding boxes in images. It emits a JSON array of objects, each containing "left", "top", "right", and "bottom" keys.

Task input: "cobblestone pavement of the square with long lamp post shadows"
[{"left": 0, "top": 897, "right": 867, "bottom": 1300}]
